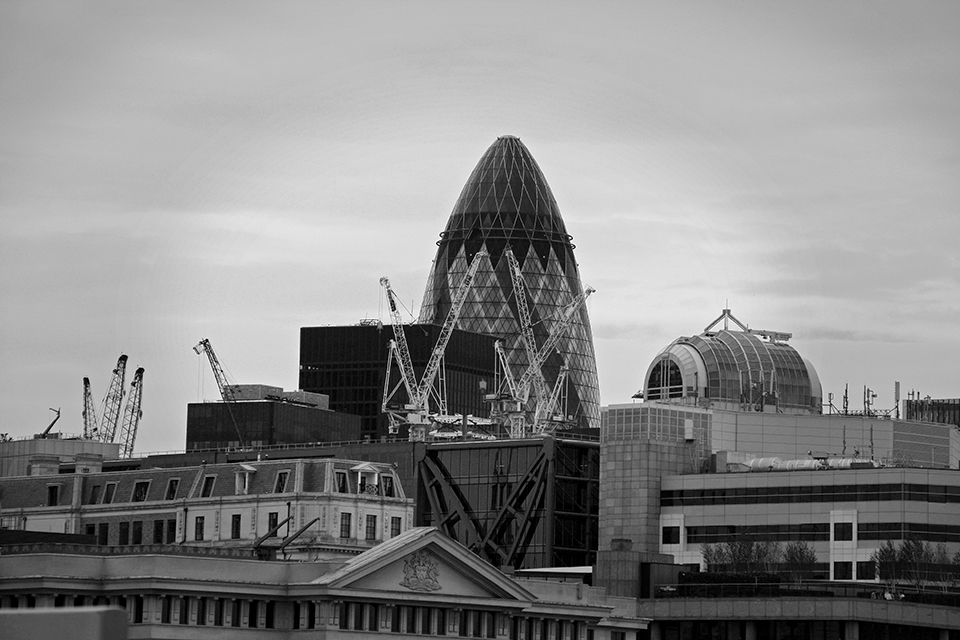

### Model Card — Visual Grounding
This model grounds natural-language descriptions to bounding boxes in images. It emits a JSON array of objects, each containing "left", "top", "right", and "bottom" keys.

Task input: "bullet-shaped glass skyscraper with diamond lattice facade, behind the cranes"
[{"left": 419, "top": 136, "right": 600, "bottom": 428}]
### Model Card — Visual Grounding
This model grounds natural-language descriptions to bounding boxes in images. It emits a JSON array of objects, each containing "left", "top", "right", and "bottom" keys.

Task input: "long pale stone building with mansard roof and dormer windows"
[{"left": 0, "top": 459, "right": 413, "bottom": 560}]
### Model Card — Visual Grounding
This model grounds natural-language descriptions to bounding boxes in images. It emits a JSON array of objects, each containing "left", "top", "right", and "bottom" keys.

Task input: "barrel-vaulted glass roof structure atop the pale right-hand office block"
[{"left": 643, "top": 316, "right": 822, "bottom": 414}]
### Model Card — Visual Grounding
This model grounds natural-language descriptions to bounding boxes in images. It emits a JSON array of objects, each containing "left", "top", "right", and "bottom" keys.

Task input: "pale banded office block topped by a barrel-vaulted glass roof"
[{"left": 597, "top": 310, "right": 960, "bottom": 593}]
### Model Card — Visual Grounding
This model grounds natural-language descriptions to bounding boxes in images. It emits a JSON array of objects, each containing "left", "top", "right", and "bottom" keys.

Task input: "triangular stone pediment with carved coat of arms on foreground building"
[{"left": 315, "top": 527, "right": 536, "bottom": 602}]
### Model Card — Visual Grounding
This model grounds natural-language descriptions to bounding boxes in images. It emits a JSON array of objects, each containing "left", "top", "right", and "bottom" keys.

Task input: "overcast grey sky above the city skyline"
[{"left": 0, "top": 0, "right": 960, "bottom": 452}]
